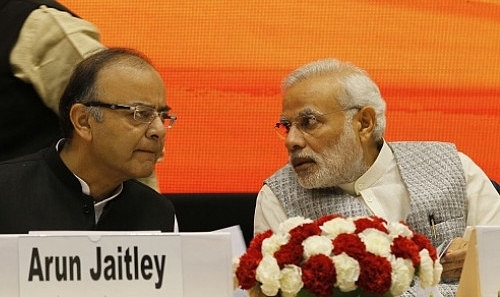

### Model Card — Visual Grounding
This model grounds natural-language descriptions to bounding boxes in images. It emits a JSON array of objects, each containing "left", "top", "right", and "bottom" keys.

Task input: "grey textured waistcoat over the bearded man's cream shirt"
[{"left": 265, "top": 142, "right": 467, "bottom": 246}]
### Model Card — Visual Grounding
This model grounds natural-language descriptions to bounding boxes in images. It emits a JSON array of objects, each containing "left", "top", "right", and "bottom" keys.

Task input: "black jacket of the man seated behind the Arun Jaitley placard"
[{"left": 0, "top": 148, "right": 174, "bottom": 234}]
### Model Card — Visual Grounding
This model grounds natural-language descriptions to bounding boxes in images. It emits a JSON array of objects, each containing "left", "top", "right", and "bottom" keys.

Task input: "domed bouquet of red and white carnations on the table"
[{"left": 233, "top": 215, "right": 443, "bottom": 297}]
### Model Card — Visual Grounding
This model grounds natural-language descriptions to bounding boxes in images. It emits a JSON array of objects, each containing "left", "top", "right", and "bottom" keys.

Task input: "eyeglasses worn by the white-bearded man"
[{"left": 274, "top": 107, "right": 361, "bottom": 139}]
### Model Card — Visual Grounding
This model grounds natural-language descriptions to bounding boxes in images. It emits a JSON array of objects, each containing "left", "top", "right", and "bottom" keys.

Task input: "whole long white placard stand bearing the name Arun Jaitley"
[{"left": 0, "top": 233, "right": 232, "bottom": 297}]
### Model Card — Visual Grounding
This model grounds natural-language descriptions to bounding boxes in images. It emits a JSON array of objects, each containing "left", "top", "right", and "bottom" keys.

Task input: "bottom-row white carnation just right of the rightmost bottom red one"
[{"left": 390, "top": 257, "right": 415, "bottom": 296}]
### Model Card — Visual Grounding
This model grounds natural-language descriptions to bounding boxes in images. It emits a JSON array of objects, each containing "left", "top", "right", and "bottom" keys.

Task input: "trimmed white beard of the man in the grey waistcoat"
[{"left": 297, "top": 121, "right": 369, "bottom": 189}]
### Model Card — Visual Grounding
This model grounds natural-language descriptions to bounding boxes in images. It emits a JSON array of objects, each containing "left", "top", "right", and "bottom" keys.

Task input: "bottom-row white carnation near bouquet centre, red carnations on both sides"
[{"left": 332, "top": 253, "right": 360, "bottom": 292}]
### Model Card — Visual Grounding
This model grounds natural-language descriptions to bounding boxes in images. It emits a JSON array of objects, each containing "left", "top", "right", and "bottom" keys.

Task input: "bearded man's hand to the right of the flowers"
[{"left": 441, "top": 237, "right": 468, "bottom": 281}]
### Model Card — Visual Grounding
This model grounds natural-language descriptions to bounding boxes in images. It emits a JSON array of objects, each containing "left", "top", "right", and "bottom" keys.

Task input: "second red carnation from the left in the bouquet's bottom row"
[{"left": 302, "top": 254, "right": 337, "bottom": 297}]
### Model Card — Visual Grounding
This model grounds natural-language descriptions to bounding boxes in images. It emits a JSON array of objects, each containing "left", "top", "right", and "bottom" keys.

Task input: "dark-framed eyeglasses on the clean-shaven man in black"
[{"left": 83, "top": 101, "right": 177, "bottom": 129}]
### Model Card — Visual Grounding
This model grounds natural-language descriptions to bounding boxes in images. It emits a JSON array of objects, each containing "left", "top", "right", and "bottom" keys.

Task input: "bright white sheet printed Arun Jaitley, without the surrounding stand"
[{"left": 19, "top": 235, "right": 182, "bottom": 297}]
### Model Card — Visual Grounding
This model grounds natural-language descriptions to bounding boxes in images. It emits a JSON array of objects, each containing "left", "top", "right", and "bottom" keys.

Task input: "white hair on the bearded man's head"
[{"left": 281, "top": 59, "right": 386, "bottom": 142}]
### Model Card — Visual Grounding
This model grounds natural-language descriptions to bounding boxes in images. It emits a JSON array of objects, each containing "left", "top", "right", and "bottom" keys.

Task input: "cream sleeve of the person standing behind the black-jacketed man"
[{"left": 10, "top": 6, "right": 104, "bottom": 114}]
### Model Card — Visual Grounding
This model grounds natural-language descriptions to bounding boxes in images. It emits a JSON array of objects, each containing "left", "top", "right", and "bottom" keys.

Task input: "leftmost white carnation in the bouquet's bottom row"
[{"left": 255, "top": 255, "right": 280, "bottom": 296}]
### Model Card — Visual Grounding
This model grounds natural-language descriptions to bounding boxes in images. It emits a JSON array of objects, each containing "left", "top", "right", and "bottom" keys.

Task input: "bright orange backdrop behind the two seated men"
[{"left": 61, "top": 0, "right": 500, "bottom": 193}]
